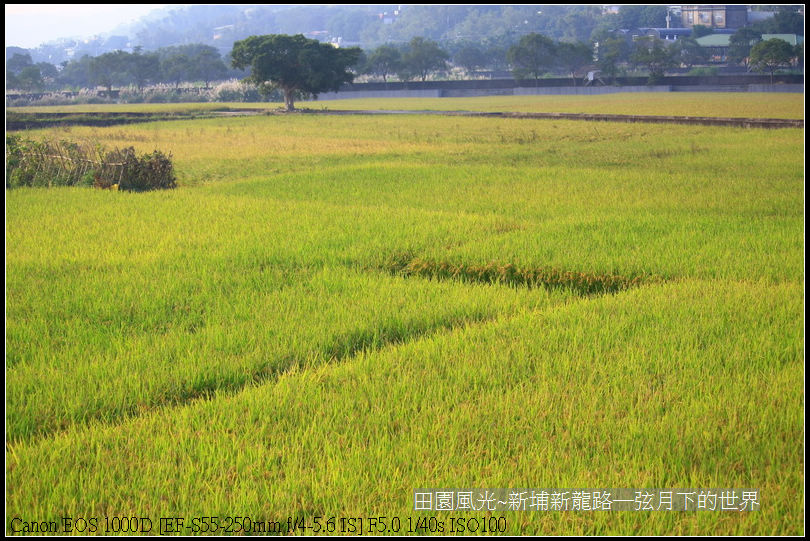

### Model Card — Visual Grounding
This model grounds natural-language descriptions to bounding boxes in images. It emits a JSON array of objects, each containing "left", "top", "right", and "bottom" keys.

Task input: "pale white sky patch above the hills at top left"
[{"left": 6, "top": 4, "right": 174, "bottom": 49}]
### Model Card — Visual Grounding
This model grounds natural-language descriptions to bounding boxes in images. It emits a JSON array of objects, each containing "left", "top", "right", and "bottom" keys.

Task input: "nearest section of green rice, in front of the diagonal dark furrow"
[{"left": 6, "top": 281, "right": 804, "bottom": 535}]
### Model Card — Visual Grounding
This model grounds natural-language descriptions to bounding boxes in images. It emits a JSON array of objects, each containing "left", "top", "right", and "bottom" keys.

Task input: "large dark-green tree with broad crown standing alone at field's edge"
[{"left": 231, "top": 34, "right": 361, "bottom": 111}]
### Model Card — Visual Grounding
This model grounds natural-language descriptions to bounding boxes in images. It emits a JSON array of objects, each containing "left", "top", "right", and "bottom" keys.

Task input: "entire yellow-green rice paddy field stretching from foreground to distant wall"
[{"left": 6, "top": 94, "right": 805, "bottom": 535}]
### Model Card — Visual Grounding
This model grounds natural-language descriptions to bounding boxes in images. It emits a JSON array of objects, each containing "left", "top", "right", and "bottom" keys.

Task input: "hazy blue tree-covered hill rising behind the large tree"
[{"left": 17, "top": 5, "right": 603, "bottom": 64}]
